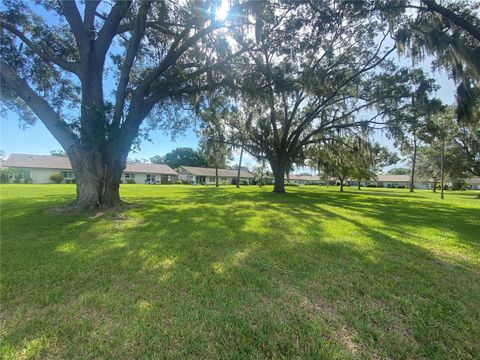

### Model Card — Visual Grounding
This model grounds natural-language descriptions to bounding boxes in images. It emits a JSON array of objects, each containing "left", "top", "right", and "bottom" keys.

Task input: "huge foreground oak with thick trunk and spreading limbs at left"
[{"left": 1, "top": 0, "right": 248, "bottom": 209}]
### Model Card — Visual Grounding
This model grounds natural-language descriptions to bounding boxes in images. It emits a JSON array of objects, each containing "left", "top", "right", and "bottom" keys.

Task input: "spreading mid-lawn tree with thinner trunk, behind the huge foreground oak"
[{"left": 227, "top": 1, "right": 408, "bottom": 193}]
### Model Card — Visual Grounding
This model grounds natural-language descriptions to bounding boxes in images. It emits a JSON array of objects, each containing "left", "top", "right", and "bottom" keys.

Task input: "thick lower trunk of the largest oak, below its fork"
[{"left": 68, "top": 149, "right": 125, "bottom": 211}]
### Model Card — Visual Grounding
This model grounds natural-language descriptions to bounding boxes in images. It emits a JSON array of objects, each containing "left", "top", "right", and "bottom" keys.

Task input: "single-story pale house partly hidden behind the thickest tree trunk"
[{"left": 2, "top": 154, "right": 178, "bottom": 184}]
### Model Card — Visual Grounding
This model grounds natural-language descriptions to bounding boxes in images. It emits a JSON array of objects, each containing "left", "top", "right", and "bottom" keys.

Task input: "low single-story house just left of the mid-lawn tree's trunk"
[{"left": 177, "top": 166, "right": 255, "bottom": 185}]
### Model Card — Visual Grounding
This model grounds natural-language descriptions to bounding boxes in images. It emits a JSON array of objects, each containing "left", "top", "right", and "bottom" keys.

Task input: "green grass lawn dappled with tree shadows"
[{"left": 1, "top": 185, "right": 480, "bottom": 359}]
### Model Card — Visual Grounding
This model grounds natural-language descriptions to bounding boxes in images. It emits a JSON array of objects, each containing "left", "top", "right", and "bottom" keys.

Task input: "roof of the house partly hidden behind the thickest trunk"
[{"left": 2, "top": 154, "right": 178, "bottom": 175}]
